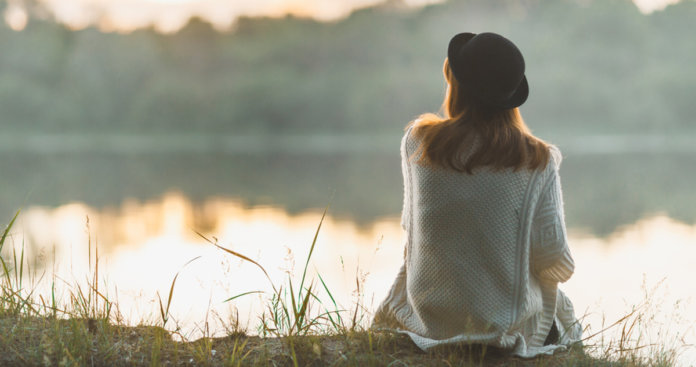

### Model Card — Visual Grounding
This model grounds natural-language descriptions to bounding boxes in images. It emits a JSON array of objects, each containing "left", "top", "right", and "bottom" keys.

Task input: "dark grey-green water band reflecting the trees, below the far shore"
[{"left": 0, "top": 135, "right": 696, "bottom": 236}]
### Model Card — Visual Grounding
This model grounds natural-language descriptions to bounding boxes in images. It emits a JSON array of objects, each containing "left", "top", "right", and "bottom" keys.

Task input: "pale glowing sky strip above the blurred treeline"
[{"left": 5, "top": 0, "right": 679, "bottom": 32}]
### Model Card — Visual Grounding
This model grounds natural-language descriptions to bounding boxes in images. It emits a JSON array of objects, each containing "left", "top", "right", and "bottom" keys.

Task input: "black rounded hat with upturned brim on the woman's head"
[{"left": 447, "top": 33, "right": 529, "bottom": 110}]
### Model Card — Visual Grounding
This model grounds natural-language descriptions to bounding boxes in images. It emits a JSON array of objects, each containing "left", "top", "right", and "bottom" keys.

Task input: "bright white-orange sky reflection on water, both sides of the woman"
[{"left": 5, "top": 194, "right": 696, "bottom": 361}]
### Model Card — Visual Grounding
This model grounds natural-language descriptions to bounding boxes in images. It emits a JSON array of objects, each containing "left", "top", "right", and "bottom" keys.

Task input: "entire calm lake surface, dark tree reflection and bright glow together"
[{"left": 0, "top": 142, "right": 696, "bottom": 364}]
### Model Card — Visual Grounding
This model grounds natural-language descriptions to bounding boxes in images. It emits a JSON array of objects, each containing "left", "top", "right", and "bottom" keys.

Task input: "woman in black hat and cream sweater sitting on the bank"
[{"left": 374, "top": 33, "right": 582, "bottom": 357}]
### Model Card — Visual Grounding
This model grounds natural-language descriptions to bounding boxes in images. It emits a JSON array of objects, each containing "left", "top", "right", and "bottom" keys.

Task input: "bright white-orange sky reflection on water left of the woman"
[{"left": 13, "top": 194, "right": 402, "bottom": 335}]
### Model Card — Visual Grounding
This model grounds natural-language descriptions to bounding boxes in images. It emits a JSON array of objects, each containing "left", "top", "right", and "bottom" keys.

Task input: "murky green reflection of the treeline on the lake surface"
[{"left": 0, "top": 151, "right": 696, "bottom": 236}]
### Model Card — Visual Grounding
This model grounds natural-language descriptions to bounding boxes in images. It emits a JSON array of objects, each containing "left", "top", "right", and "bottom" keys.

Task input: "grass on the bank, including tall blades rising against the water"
[{"left": 0, "top": 208, "right": 675, "bottom": 367}]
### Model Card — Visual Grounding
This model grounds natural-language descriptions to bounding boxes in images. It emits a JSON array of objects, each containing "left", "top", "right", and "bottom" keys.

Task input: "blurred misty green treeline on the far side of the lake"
[{"left": 0, "top": 0, "right": 696, "bottom": 133}]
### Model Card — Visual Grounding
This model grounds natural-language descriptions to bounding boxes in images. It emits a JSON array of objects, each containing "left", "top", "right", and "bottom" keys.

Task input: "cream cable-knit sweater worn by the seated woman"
[{"left": 373, "top": 125, "right": 582, "bottom": 357}]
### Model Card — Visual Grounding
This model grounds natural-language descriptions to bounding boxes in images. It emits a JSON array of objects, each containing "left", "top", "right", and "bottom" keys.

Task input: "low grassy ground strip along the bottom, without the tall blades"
[{"left": 0, "top": 315, "right": 671, "bottom": 367}]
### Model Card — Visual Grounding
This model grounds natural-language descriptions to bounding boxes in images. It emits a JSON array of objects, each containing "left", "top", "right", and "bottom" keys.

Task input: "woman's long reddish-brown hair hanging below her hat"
[{"left": 407, "top": 59, "right": 550, "bottom": 174}]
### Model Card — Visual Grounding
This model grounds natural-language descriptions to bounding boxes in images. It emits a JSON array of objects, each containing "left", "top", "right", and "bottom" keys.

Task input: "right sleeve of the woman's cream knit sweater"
[{"left": 531, "top": 147, "right": 575, "bottom": 282}]
